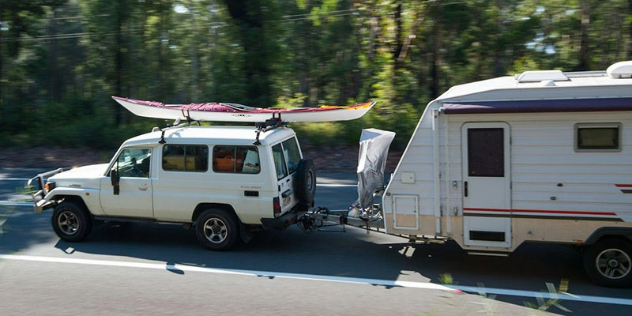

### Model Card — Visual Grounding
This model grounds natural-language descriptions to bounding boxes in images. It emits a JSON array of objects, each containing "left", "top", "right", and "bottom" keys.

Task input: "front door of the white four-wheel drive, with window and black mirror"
[{"left": 100, "top": 148, "right": 153, "bottom": 218}]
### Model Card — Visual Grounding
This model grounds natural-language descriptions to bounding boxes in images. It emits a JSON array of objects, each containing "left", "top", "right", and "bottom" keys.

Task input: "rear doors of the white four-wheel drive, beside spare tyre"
[{"left": 272, "top": 137, "right": 301, "bottom": 213}]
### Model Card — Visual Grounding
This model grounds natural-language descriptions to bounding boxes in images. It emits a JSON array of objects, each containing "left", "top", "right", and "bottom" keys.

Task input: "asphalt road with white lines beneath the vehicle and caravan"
[{"left": 0, "top": 169, "right": 632, "bottom": 316}]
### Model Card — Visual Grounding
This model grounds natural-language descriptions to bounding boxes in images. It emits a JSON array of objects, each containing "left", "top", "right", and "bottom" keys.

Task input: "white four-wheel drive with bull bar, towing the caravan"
[{"left": 29, "top": 125, "right": 316, "bottom": 250}]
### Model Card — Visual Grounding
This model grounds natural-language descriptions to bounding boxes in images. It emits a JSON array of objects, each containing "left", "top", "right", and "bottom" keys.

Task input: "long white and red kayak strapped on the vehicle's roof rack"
[{"left": 112, "top": 96, "right": 375, "bottom": 123}]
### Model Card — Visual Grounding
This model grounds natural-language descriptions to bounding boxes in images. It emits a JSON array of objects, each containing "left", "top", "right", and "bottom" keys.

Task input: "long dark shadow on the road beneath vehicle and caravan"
[{"left": 0, "top": 205, "right": 632, "bottom": 315}]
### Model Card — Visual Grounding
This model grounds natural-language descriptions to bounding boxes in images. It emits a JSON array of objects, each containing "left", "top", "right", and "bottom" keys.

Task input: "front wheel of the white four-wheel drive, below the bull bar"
[{"left": 51, "top": 201, "right": 92, "bottom": 242}]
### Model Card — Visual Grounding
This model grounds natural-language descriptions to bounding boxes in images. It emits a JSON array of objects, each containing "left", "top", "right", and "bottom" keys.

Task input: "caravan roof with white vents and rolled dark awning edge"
[{"left": 433, "top": 61, "right": 632, "bottom": 114}]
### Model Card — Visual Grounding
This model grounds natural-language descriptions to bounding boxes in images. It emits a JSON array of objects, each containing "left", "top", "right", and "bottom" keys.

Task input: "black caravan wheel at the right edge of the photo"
[{"left": 584, "top": 238, "right": 632, "bottom": 287}]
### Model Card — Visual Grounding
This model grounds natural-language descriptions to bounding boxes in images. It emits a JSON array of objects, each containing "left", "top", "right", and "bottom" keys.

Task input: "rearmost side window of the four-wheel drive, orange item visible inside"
[{"left": 213, "top": 145, "right": 261, "bottom": 174}]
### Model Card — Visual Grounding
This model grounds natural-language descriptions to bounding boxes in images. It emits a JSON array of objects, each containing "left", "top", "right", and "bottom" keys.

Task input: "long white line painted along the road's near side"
[{"left": 0, "top": 255, "right": 632, "bottom": 306}]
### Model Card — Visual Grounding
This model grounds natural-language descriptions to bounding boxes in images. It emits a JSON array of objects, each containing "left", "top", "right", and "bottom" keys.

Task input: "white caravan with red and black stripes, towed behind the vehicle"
[{"left": 382, "top": 61, "right": 632, "bottom": 286}]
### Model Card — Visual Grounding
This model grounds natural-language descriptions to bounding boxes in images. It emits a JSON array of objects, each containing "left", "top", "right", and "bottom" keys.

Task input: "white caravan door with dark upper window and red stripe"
[{"left": 462, "top": 122, "right": 511, "bottom": 248}]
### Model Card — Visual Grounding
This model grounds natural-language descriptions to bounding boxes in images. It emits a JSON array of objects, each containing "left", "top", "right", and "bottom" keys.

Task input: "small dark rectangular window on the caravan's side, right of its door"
[{"left": 575, "top": 123, "right": 621, "bottom": 152}]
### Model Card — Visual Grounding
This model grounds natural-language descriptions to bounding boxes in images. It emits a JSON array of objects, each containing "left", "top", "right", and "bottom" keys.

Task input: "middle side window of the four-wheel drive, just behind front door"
[{"left": 162, "top": 145, "right": 208, "bottom": 172}]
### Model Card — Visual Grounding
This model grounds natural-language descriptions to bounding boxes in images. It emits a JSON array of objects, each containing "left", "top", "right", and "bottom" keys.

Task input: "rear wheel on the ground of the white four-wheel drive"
[{"left": 195, "top": 209, "right": 239, "bottom": 251}]
